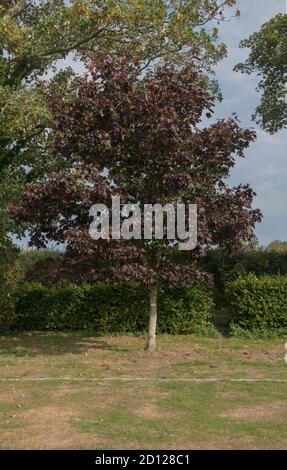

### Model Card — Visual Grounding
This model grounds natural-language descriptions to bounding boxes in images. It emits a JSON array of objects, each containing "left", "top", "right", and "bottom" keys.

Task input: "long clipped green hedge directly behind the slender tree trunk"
[{"left": 0, "top": 284, "right": 214, "bottom": 334}]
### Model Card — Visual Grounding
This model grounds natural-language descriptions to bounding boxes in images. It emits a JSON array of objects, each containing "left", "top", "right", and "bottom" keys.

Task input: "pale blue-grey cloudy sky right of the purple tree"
[{"left": 216, "top": 0, "right": 287, "bottom": 245}]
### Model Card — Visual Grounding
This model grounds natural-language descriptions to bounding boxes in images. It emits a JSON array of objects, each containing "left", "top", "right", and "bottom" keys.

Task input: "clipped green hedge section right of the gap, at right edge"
[{"left": 225, "top": 274, "right": 287, "bottom": 336}]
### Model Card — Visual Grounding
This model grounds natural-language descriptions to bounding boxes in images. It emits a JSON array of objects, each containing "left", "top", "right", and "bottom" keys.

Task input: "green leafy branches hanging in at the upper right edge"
[{"left": 235, "top": 14, "right": 287, "bottom": 134}]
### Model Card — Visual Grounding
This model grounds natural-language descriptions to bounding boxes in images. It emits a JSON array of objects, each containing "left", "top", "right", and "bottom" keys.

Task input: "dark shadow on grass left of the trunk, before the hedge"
[{"left": 0, "top": 332, "right": 125, "bottom": 358}]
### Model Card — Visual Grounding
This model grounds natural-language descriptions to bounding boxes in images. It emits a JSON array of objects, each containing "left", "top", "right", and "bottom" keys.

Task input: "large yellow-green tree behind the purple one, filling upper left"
[{"left": 0, "top": 0, "right": 238, "bottom": 253}]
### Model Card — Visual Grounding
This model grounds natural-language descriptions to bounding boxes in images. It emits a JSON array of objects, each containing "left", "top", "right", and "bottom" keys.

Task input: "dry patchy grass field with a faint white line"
[{"left": 0, "top": 333, "right": 287, "bottom": 449}]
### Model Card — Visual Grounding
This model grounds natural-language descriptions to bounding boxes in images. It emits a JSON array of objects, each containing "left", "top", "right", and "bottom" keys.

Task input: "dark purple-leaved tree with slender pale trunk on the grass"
[{"left": 9, "top": 56, "right": 261, "bottom": 350}]
